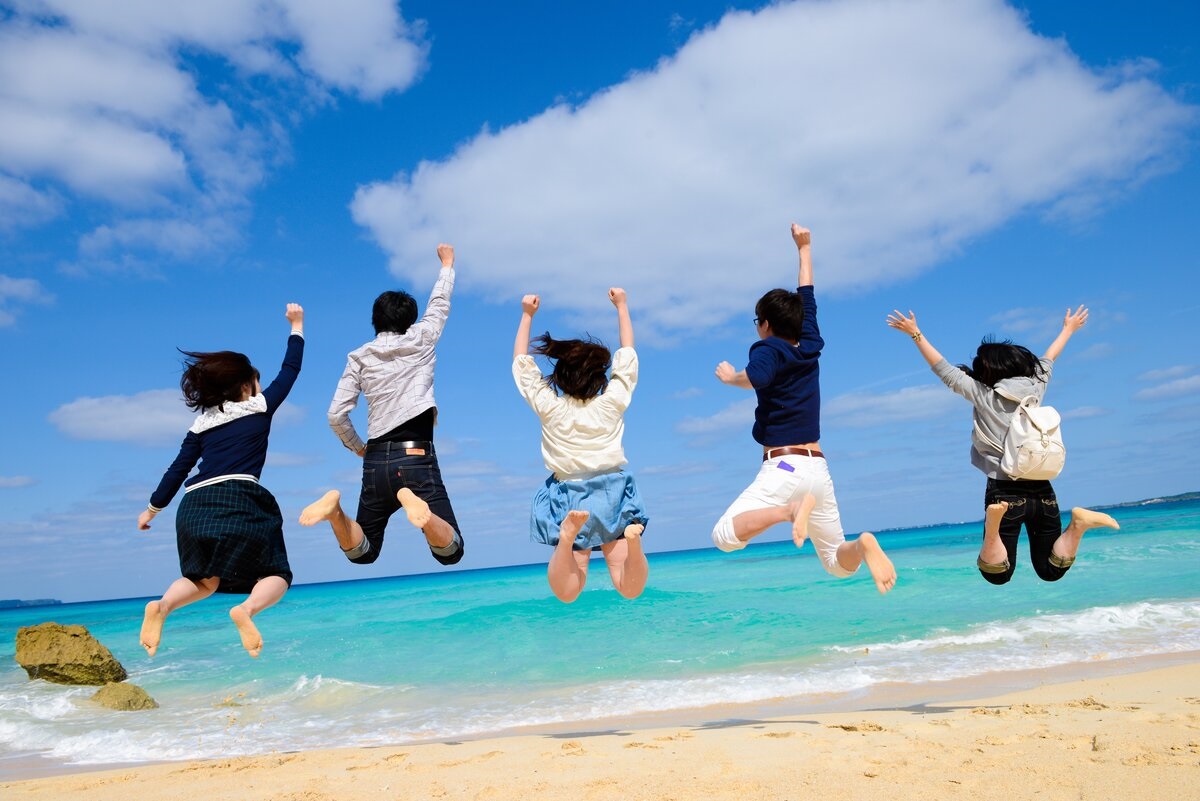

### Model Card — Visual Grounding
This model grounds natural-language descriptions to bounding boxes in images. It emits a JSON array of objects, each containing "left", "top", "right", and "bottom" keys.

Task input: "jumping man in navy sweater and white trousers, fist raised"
[{"left": 713, "top": 223, "right": 896, "bottom": 594}]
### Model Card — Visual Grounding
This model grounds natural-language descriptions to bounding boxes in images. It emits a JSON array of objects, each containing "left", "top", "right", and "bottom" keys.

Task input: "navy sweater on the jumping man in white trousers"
[{"left": 746, "top": 287, "right": 824, "bottom": 447}]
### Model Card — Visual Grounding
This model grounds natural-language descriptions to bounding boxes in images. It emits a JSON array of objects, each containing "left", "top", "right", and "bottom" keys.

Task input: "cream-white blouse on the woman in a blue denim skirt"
[{"left": 512, "top": 348, "right": 637, "bottom": 481}]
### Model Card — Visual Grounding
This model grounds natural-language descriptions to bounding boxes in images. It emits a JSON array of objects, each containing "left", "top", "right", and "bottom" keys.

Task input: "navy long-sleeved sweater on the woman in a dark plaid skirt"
[{"left": 150, "top": 335, "right": 304, "bottom": 510}]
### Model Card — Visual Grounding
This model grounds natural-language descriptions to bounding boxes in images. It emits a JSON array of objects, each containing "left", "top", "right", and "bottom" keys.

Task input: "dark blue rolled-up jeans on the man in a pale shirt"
[{"left": 348, "top": 442, "right": 463, "bottom": 565}]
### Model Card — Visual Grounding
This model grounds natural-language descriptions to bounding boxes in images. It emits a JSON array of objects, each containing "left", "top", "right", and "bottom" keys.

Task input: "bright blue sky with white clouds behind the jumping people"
[{"left": 0, "top": 0, "right": 1200, "bottom": 601}]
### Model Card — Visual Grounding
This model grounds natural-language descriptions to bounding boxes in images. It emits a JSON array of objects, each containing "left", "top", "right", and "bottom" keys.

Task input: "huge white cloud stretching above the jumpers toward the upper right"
[{"left": 352, "top": 0, "right": 1195, "bottom": 332}]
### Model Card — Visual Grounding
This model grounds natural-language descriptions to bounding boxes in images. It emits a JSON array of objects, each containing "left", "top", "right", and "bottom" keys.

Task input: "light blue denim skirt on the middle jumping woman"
[{"left": 529, "top": 470, "right": 650, "bottom": 550}]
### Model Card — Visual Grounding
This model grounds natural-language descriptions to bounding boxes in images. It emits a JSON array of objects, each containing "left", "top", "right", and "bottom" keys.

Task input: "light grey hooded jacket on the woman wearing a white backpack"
[{"left": 934, "top": 359, "right": 1054, "bottom": 478}]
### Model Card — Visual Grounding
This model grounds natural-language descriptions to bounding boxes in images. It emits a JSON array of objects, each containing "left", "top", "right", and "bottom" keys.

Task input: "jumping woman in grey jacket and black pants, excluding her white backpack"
[{"left": 888, "top": 306, "right": 1121, "bottom": 584}]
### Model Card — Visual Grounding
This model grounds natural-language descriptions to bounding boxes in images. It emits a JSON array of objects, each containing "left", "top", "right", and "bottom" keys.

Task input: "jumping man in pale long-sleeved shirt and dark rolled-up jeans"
[{"left": 300, "top": 245, "right": 463, "bottom": 565}]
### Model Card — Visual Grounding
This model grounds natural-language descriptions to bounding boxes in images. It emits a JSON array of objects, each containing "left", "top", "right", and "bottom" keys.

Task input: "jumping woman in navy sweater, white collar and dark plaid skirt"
[{"left": 138, "top": 303, "right": 304, "bottom": 657}]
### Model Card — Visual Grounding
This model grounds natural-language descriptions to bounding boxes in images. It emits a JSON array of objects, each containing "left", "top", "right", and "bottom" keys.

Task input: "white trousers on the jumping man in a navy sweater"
[{"left": 713, "top": 456, "right": 854, "bottom": 578}]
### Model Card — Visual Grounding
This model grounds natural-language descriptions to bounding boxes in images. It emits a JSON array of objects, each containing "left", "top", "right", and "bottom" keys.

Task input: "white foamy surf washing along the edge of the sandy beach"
[{"left": 0, "top": 601, "right": 1200, "bottom": 764}]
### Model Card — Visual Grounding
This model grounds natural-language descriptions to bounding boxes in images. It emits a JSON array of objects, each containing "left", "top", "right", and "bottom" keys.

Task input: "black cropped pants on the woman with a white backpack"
[{"left": 979, "top": 478, "right": 1070, "bottom": 584}]
